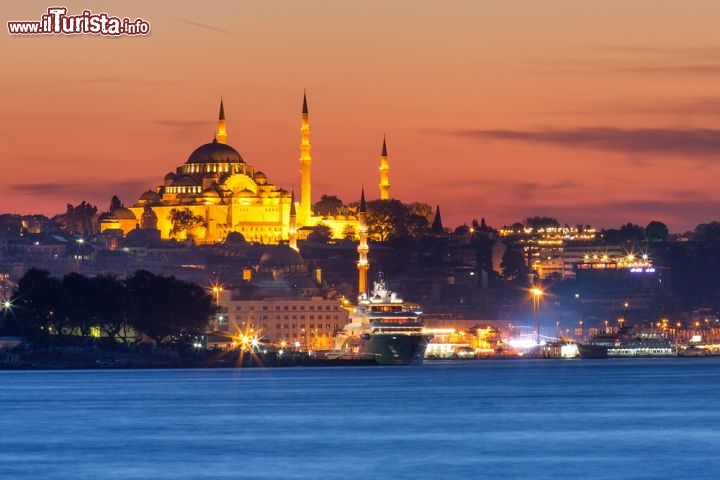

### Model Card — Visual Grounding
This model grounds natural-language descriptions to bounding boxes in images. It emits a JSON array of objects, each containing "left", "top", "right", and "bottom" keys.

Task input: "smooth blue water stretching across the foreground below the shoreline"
[{"left": 0, "top": 358, "right": 720, "bottom": 480}]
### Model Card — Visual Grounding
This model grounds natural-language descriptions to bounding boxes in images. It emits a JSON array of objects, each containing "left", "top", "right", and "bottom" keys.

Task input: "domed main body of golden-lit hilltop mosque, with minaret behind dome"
[{"left": 124, "top": 101, "right": 291, "bottom": 244}]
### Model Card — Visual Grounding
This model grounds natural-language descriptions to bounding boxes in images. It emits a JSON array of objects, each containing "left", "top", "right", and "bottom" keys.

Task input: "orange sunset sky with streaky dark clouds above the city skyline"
[{"left": 0, "top": 0, "right": 720, "bottom": 232}]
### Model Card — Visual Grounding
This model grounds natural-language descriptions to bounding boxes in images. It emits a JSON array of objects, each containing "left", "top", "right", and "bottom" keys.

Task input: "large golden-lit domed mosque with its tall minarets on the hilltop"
[{"left": 101, "top": 95, "right": 390, "bottom": 246}]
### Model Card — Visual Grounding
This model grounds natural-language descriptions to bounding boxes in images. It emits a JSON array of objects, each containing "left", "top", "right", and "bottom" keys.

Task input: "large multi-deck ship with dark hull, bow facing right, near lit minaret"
[{"left": 335, "top": 276, "right": 432, "bottom": 365}]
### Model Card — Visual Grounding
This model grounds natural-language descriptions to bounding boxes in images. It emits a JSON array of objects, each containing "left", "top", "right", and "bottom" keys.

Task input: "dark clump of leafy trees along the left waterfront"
[{"left": 3, "top": 268, "right": 216, "bottom": 344}]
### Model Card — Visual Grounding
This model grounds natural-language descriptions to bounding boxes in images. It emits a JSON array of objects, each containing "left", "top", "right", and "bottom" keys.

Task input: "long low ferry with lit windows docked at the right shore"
[{"left": 577, "top": 326, "right": 678, "bottom": 358}]
